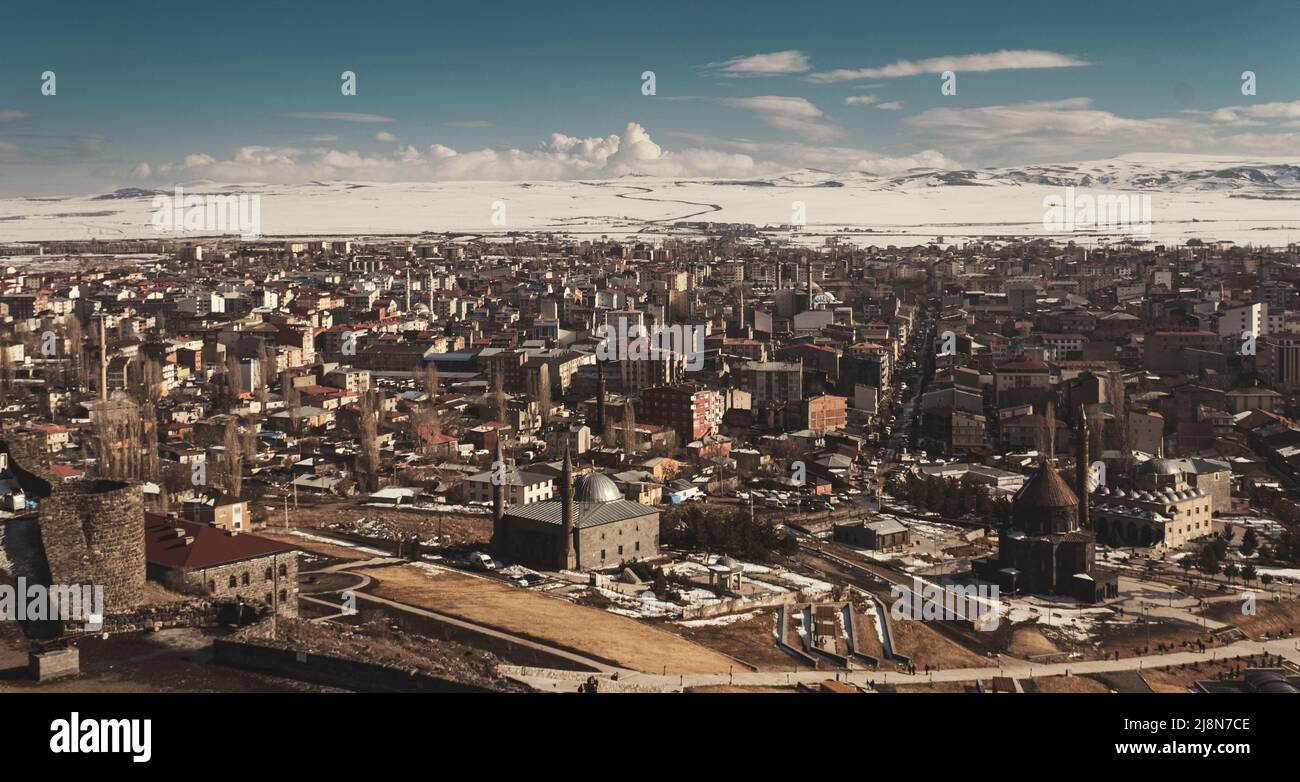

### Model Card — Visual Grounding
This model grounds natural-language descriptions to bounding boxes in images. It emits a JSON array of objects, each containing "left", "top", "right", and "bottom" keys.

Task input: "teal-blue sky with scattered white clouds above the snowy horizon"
[{"left": 0, "top": 0, "right": 1300, "bottom": 197}]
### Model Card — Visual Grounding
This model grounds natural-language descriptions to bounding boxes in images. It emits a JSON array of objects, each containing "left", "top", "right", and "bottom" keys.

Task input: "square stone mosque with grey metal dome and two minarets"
[{"left": 491, "top": 451, "right": 659, "bottom": 570}]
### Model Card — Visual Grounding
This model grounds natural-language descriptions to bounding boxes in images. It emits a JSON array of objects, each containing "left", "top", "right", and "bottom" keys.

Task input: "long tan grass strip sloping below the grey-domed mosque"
[{"left": 358, "top": 565, "right": 736, "bottom": 673}]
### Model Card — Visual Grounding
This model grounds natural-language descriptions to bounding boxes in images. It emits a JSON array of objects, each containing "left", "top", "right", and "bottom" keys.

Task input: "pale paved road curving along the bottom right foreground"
[{"left": 502, "top": 638, "right": 1300, "bottom": 692}]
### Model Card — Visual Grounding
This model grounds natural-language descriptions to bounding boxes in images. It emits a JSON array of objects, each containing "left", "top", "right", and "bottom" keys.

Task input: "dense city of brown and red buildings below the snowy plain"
[{"left": 0, "top": 225, "right": 1300, "bottom": 692}]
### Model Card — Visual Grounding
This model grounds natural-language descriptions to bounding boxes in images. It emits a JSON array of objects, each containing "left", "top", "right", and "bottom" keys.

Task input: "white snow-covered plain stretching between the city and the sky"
[{"left": 0, "top": 155, "right": 1300, "bottom": 247}]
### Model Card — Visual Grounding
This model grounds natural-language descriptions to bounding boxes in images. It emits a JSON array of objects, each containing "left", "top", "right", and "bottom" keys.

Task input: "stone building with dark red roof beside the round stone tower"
[{"left": 144, "top": 513, "right": 298, "bottom": 616}]
